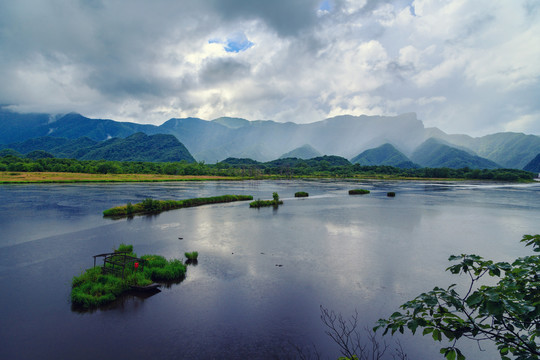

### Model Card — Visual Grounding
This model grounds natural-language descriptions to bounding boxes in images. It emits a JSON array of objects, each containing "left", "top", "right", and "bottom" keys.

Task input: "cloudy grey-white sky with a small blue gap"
[{"left": 0, "top": 0, "right": 540, "bottom": 136}]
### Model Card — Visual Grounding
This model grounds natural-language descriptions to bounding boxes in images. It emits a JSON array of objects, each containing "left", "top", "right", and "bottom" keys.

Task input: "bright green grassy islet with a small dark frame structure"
[{"left": 71, "top": 244, "right": 191, "bottom": 309}]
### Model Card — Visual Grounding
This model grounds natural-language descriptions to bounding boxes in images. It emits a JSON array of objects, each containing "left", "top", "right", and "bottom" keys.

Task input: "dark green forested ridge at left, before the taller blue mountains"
[{"left": 0, "top": 133, "right": 195, "bottom": 162}]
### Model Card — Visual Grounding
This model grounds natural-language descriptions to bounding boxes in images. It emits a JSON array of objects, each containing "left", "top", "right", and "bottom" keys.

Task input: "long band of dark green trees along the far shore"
[{"left": 0, "top": 154, "right": 535, "bottom": 181}]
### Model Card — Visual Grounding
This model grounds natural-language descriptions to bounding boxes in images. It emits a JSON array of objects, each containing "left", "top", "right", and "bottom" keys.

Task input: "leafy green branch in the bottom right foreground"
[{"left": 374, "top": 235, "right": 540, "bottom": 360}]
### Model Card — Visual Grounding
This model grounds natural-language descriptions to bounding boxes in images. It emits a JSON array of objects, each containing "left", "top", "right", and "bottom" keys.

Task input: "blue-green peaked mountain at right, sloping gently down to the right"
[{"left": 411, "top": 138, "right": 500, "bottom": 169}]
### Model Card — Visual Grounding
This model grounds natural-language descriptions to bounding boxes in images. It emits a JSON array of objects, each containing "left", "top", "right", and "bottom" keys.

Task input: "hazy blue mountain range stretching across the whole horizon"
[{"left": 0, "top": 109, "right": 540, "bottom": 169}]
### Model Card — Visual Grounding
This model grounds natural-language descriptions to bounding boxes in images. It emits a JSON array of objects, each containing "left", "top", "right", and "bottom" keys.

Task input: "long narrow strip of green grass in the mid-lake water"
[{"left": 103, "top": 195, "right": 253, "bottom": 218}]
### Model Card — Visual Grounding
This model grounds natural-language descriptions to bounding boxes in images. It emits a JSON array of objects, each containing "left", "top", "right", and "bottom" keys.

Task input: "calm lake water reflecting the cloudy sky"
[{"left": 0, "top": 180, "right": 540, "bottom": 359}]
